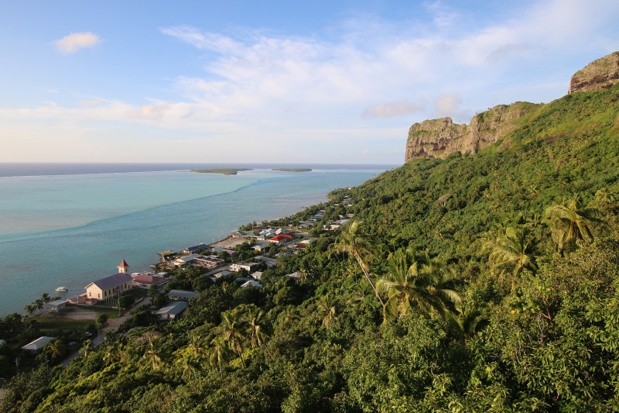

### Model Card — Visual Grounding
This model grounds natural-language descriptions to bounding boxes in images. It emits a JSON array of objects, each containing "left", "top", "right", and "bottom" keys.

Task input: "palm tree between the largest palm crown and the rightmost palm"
[{"left": 484, "top": 227, "right": 537, "bottom": 291}]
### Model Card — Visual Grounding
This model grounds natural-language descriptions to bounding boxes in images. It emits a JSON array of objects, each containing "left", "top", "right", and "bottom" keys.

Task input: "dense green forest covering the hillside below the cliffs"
[{"left": 3, "top": 83, "right": 619, "bottom": 412}]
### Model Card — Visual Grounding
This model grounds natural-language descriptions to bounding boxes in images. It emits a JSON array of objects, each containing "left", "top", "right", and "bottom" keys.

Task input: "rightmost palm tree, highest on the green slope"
[{"left": 545, "top": 195, "right": 604, "bottom": 254}]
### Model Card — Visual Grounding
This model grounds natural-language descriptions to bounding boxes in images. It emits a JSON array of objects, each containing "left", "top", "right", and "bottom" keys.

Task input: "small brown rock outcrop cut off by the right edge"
[{"left": 568, "top": 52, "right": 619, "bottom": 93}]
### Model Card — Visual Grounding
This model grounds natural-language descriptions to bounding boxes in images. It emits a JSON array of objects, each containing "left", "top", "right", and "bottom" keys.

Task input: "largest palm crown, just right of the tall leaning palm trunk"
[{"left": 377, "top": 250, "right": 461, "bottom": 322}]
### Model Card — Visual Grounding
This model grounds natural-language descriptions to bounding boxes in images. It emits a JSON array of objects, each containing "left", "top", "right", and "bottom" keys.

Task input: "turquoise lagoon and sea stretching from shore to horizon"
[{"left": 0, "top": 164, "right": 395, "bottom": 316}]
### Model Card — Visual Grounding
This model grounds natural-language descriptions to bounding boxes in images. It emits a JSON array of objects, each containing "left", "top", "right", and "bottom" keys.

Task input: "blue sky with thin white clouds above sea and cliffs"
[{"left": 0, "top": 0, "right": 619, "bottom": 164}]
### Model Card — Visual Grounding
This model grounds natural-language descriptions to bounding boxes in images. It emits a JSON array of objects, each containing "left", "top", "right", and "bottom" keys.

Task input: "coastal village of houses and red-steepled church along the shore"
[{"left": 0, "top": 198, "right": 353, "bottom": 362}]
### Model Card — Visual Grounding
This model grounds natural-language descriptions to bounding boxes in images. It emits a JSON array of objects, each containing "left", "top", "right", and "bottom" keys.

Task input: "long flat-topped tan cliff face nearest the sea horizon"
[{"left": 405, "top": 102, "right": 536, "bottom": 161}]
